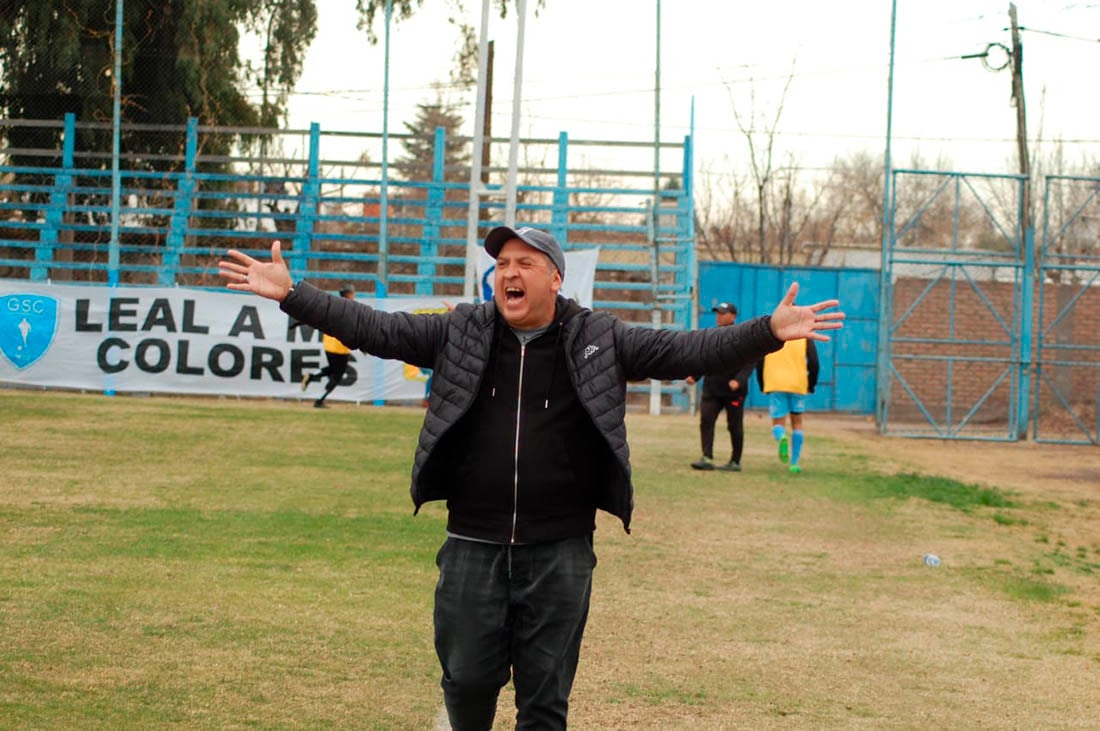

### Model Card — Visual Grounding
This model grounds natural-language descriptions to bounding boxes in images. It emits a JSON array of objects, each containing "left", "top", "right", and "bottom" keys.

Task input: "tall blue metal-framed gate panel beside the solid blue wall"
[{"left": 877, "top": 170, "right": 1034, "bottom": 440}]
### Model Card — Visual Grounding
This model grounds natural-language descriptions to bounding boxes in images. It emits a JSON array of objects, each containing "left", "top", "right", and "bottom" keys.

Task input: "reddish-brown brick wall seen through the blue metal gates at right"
[{"left": 888, "top": 276, "right": 1100, "bottom": 431}]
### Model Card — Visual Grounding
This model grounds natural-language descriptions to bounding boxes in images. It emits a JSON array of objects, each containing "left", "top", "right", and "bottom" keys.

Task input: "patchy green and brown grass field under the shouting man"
[{"left": 0, "top": 389, "right": 1100, "bottom": 729}]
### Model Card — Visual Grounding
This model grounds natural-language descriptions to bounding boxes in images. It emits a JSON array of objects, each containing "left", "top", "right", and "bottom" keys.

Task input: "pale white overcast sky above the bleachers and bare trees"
[{"left": 251, "top": 0, "right": 1100, "bottom": 180}]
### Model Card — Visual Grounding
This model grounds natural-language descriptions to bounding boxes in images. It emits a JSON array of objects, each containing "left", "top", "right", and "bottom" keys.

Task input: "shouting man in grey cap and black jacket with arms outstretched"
[{"left": 218, "top": 226, "right": 844, "bottom": 731}]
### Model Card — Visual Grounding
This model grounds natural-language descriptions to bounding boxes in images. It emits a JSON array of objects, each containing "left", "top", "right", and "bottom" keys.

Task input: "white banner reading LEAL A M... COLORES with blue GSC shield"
[{"left": 0, "top": 279, "right": 462, "bottom": 401}]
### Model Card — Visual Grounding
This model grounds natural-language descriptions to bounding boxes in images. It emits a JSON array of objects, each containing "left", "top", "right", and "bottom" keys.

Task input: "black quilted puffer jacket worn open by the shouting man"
[{"left": 281, "top": 283, "right": 782, "bottom": 531}]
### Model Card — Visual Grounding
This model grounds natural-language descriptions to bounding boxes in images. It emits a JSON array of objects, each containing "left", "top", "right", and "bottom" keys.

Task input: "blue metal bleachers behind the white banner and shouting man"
[{"left": 0, "top": 114, "right": 696, "bottom": 406}]
